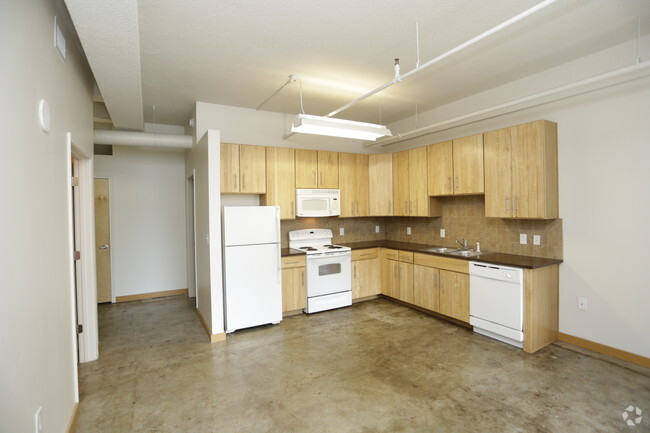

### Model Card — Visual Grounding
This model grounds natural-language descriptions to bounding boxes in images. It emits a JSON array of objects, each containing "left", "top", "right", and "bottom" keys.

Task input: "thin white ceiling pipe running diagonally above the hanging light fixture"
[{"left": 325, "top": 0, "right": 558, "bottom": 117}]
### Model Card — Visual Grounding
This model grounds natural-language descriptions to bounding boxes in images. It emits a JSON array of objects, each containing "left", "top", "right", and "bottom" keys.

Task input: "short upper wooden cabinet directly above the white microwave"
[{"left": 296, "top": 149, "right": 339, "bottom": 189}]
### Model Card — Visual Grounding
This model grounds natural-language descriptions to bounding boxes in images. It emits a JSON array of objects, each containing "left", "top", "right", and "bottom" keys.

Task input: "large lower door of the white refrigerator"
[{"left": 224, "top": 244, "right": 282, "bottom": 332}]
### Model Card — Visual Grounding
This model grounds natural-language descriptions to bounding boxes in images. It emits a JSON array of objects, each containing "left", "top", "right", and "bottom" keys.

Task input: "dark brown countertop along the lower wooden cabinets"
[{"left": 281, "top": 240, "right": 562, "bottom": 269}]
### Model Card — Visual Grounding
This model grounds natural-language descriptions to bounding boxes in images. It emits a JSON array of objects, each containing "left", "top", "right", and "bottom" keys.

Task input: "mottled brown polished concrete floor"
[{"left": 76, "top": 297, "right": 650, "bottom": 433}]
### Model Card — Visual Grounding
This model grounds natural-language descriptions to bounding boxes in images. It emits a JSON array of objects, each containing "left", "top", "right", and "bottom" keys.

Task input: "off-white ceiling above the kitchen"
[{"left": 66, "top": 0, "right": 650, "bottom": 128}]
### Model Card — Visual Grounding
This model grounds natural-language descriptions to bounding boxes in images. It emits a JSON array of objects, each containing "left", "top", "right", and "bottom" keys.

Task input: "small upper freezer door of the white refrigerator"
[{"left": 223, "top": 206, "right": 280, "bottom": 247}]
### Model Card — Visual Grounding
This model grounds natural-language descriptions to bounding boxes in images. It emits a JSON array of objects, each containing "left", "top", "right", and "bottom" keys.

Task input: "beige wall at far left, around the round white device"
[{"left": 0, "top": 0, "right": 92, "bottom": 432}]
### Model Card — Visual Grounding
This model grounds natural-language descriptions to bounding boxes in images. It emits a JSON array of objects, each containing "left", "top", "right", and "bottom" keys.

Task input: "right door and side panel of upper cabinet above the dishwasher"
[{"left": 512, "top": 121, "right": 558, "bottom": 218}]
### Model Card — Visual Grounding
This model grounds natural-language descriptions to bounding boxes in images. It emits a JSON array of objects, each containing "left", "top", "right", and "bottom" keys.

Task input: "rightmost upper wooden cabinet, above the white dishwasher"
[{"left": 484, "top": 120, "right": 558, "bottom": 219}]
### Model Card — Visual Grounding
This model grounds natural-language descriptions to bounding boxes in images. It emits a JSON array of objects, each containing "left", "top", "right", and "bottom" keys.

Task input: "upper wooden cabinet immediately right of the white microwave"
[{"left": 339, "top": 153, "right": 370, "bottom": 217}]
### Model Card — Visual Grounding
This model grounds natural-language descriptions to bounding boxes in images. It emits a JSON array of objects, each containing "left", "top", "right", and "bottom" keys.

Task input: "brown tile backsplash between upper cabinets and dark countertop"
[{"left": 282, "top": 196, "right": 562, "bottom": 259}]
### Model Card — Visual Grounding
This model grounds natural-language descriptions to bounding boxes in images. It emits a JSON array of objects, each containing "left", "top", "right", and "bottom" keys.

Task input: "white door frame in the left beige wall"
[{"left": 65, "top": 132, "right": 99, "bottom": 364}]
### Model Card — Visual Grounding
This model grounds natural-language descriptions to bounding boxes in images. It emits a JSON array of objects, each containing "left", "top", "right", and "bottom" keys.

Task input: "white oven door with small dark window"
[{"left": 307, "top": 251, "right": 352, "bottom": 297}]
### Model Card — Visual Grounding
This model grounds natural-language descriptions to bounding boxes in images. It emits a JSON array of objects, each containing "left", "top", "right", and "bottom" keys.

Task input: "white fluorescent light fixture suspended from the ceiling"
[{"left": 291, "top": 114, "right": 393, "bottom": 141}]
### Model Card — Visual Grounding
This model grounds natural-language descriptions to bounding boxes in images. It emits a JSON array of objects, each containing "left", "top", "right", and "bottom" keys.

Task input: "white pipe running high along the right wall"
[{"left": 364, "top": 60, "right": 650, "bottom": 147}]
